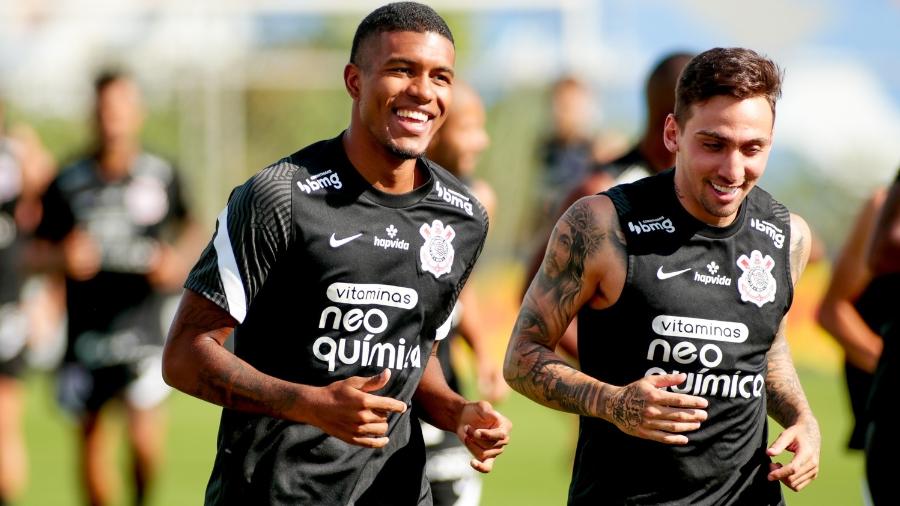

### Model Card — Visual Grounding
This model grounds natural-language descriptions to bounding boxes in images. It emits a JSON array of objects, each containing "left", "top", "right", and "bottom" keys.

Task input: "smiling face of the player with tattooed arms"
[{"left": 664, "top": 95, "right": 775, "bottom": 226}]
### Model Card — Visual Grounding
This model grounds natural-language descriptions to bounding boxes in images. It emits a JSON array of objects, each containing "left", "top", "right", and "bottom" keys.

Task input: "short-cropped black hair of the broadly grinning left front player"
[{"left": 350, "top": 2, "right": 453, "bottom": 65}]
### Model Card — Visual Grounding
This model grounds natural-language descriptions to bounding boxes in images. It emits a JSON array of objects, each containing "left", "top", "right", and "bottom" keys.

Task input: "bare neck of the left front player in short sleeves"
[{"left": 341, "top": 128, "right": 426, "bottom": 194}]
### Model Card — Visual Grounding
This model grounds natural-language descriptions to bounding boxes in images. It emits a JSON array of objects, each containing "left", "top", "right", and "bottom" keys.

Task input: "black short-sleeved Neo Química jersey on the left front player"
[{"left": 185, "top": 137, "right": 487, "bottom": 505}]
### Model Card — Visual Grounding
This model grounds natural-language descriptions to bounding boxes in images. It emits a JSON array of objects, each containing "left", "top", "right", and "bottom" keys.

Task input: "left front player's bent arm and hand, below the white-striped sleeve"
[{"left": 163, "top": 290, "right": 406, "bottom": 448}]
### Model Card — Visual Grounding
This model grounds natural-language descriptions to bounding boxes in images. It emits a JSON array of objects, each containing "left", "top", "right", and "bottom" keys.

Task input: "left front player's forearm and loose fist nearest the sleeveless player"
[{"left": 414, "top": 343, "right": 512, "bottom": 473}]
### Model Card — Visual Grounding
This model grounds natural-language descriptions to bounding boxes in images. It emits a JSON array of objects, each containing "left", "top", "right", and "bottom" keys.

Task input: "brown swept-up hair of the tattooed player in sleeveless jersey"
[{"left": 675, "top": 47, "right": 784, "bottom": 125}]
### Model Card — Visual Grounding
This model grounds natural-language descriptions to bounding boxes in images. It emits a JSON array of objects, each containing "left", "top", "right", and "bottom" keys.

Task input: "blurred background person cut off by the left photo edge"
[{"left": 0, "top": 99, "right": 61, "bottom": 505}]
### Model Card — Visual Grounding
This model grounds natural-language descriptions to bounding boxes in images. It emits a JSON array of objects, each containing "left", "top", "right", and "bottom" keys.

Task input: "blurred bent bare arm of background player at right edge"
[{"left": 817, "top": 190, "right": 886, "bottom": 373}]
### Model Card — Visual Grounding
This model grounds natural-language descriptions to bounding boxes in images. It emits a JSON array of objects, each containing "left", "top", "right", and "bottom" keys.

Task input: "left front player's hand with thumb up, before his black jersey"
[{"left": 306, "top": 369, "right": 406, "bottom": 448}]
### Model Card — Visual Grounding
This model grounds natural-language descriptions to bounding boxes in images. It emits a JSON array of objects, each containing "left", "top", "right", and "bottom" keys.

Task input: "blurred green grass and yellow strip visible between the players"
[{"left": 16, "top": 266, "right": 863, "bottom": 506}]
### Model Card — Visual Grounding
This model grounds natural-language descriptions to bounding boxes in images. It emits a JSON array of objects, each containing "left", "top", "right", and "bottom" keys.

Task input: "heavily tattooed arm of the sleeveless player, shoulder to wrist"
[{"left": 506, "top": 201, "right": 621, "bottom": 416}]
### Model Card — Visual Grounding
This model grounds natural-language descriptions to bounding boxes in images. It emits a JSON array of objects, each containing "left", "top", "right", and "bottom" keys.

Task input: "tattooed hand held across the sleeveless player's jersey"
[{"left": 604, "top": 373, "right": 708, "bottom": 445}]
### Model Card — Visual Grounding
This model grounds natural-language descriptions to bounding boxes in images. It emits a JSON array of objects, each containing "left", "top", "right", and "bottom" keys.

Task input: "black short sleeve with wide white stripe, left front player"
[{"left": 184, "top": 160, "right": 297, "bottom": 322}]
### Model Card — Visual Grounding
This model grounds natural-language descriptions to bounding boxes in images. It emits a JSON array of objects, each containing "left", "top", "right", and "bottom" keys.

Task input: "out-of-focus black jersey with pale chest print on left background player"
[{"left": 35, "top": 153, "right": 187, "bottom": 369}]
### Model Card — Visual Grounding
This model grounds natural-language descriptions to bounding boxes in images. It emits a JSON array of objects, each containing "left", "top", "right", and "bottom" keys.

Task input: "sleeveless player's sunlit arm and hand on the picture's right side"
[{"left": 766, "top": 214, "right": 822, "bottom": 491}]
